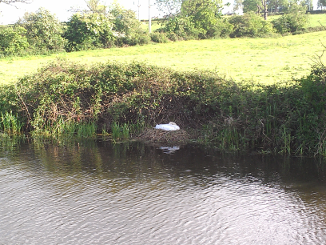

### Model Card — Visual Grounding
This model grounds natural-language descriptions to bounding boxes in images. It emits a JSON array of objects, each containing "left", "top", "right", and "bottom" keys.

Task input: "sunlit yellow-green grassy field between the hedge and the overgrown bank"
[{"left": 0, "top": 31, "right": 326, "bottom": 84}]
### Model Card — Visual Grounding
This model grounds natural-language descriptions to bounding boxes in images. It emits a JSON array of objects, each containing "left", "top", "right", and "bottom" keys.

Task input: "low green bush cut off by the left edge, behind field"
[{"left": 0, "top": 27, "right": 29, "bottom": 56}]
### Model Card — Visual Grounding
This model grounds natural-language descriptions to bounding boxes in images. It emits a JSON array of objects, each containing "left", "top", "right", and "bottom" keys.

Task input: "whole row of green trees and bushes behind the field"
[{"left": 0, "top": 0, "right": 320, "bottom": 56}]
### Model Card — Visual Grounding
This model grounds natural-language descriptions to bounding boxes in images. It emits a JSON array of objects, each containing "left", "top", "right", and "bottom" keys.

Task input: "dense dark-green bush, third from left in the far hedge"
[{"left": 64, "top": 13, "right": 115, "bottom": 51}]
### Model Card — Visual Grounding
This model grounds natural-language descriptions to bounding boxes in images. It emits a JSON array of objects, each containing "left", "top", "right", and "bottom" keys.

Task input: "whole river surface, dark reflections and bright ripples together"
[{"left": 0, "top": 139, "right": 326, "bottom": 245}]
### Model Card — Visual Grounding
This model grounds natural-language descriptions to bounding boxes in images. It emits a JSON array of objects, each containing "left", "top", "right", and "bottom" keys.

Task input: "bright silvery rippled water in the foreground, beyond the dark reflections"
[{"left": 0, "top": 145, "right": 326, "bottom": 245}]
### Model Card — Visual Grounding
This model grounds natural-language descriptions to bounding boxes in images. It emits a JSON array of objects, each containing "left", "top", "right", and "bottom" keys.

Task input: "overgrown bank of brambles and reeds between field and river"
[{"left": 0, "top": 61, "right": 326, "bottom": 155}]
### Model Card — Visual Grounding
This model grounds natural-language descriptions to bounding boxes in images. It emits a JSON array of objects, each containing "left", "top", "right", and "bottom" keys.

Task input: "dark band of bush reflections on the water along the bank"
[{"left": 1, "top": 140, "right": 326, "bottom": 184}]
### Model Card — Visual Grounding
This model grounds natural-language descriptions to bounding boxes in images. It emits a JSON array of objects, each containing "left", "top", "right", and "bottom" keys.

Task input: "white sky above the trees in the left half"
[{"left": 0, "top": 0, "right": 159, "bottom": 25}]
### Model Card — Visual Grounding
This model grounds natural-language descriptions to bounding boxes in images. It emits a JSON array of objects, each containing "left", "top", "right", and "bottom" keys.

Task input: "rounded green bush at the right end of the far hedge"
[{"left": 272, "top": 4, "right": 308, "bottom": 34}]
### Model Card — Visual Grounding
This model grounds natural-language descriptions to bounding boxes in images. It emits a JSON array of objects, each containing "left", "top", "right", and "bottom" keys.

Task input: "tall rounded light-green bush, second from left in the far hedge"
[{"left": 17, "top": 8, "right": 65, "bottom": 51}]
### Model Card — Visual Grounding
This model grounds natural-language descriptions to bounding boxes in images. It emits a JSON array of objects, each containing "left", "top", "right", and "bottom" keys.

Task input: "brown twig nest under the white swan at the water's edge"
[{"left": 137, "top": 129, "right": 189, "bottom": 144}]
